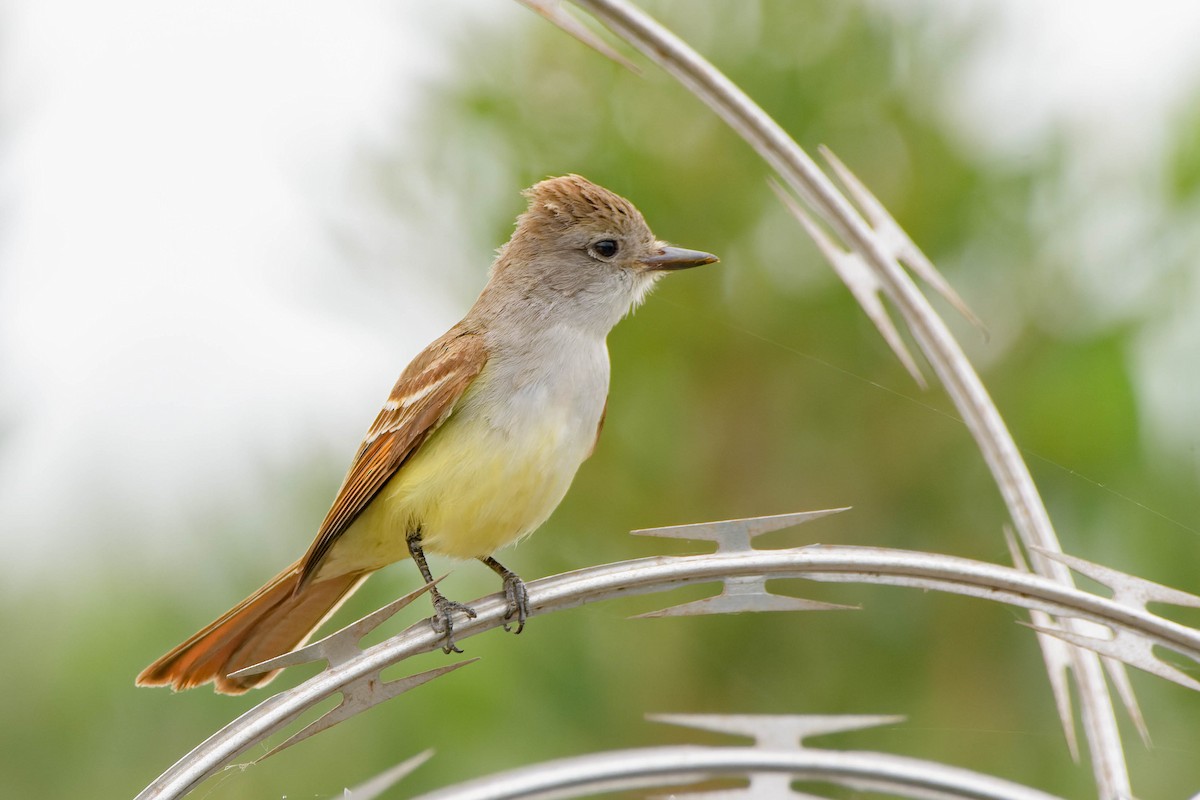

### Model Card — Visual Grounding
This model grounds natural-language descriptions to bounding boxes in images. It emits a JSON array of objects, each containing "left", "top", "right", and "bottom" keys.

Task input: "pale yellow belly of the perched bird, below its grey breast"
[{"left": 318, "top": 407, "right": 590, "bottom": 576}]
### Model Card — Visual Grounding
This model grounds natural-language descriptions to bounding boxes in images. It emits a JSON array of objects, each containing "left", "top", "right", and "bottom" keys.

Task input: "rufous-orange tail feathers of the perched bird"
[{"left": 136, "top": 561, "right": 370, "bottom": 694}]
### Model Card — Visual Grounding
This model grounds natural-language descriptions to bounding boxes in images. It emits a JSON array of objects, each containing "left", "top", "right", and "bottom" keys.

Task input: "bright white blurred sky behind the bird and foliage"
[{"left": 0, "top": 0, "right": 1200, "bottom": 584}]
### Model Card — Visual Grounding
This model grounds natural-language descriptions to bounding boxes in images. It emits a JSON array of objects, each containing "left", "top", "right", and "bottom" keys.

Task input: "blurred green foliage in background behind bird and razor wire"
[{"left": 0, "top": 1, "right": 1200, "bottom": 800}]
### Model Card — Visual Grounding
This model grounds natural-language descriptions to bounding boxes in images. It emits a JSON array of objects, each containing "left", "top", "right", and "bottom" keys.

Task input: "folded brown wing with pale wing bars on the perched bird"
[{"left": 300, "top": 326, "right": 487, "bottom": 585}]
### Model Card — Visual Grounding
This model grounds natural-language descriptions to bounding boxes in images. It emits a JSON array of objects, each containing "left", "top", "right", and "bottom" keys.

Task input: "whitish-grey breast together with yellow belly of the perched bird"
[{"left": 328, "top": 326, "right": 608, "bottom": 566}]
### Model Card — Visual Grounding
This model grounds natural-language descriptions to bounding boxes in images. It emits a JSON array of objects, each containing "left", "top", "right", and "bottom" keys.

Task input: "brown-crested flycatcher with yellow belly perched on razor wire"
[{"left": 137, "top": 175, "right": 716, "bottom": 694}]
